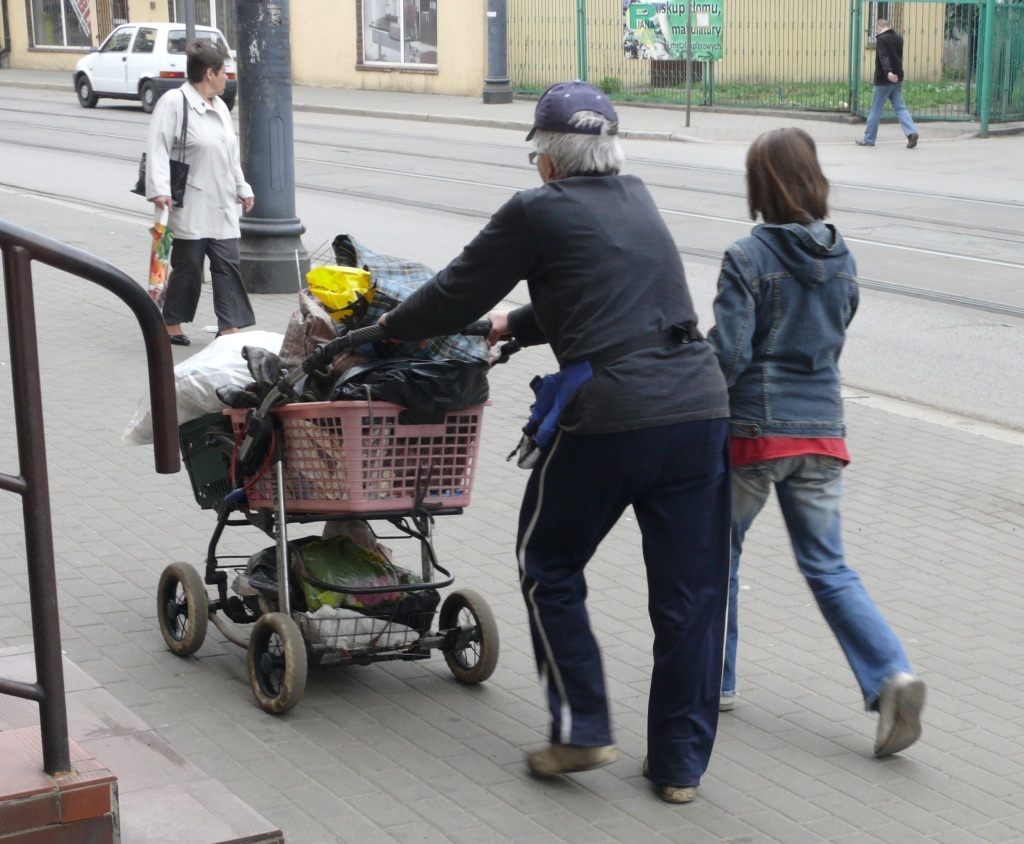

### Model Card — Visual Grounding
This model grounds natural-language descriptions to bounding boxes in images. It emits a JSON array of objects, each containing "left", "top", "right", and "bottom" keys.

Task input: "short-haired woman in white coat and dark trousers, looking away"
[{"left": 145, "top": 41, "right": 256, "bottom": 346}]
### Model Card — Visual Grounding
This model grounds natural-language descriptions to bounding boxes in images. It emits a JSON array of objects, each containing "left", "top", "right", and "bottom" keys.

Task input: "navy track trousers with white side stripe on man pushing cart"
[{"left": 517, "top": 419, "right": 730, "bottom": 787}]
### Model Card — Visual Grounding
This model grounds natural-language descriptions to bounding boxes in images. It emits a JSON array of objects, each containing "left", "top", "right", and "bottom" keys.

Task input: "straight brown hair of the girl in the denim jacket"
[{"left": 746, "top": 128, "right": 828, "bottom": 224}]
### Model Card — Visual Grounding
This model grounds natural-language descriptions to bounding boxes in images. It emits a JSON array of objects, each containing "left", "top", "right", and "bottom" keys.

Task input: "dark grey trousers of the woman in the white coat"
[{"left": 164, "top": 238, "right": 256, "bottom": 331}]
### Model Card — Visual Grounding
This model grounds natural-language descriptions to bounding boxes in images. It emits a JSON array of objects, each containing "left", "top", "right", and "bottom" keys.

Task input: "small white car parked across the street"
[{"left": 74, "top": 24, "right": 239, "bottom": 114}]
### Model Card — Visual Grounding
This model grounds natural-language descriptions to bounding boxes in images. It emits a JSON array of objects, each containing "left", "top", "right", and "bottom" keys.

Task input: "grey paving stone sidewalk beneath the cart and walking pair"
[{"left": 0, "top": 181, "right": 1024, "bottom": 844}]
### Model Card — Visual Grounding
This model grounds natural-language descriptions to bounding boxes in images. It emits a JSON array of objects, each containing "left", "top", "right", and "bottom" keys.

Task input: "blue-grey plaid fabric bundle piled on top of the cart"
[{"left": 331, "top": 235, "right": 489, "bottom": 366}]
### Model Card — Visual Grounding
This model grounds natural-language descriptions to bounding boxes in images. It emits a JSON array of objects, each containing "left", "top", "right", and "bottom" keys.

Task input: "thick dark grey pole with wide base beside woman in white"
[{"left": 238, "top": 0, "right": 309, "bottom": 293}]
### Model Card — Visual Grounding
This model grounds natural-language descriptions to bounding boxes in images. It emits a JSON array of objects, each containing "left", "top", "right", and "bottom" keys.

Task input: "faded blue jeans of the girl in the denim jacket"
[{"left": 722, "top": 455, "right": 912, "bottom": 710}]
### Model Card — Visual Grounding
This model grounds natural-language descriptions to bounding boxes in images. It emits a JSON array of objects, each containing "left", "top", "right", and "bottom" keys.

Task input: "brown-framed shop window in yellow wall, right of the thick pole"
[{"left": 356, "top": 0, "right": 437, "bottom": 68}]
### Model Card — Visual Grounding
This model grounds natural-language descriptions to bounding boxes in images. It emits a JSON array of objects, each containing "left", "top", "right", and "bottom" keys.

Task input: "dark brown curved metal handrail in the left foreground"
[{"left": 0, "top": 220, "right": 181, "bottom": 775}]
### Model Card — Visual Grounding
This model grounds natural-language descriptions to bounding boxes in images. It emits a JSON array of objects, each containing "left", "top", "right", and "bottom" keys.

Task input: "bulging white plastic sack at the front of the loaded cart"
[{"left": 121, "top": 331, "right": 285, "bottom": 446}]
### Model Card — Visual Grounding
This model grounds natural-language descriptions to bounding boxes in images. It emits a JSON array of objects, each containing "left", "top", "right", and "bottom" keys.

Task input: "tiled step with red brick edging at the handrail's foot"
[{"left": 0, "top": 647, "right": 285, "bottom": 844}]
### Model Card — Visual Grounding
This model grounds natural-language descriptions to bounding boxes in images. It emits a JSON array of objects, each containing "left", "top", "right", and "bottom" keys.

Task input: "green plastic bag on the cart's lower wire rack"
[{"left": 292, "top": 537, "right": 423, "bottom": 613}]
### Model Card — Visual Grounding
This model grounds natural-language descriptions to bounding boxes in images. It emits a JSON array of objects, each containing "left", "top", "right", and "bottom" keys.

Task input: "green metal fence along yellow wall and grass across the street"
[{"left": 508, "top": 0, "right": 1024, "bottom": 125}]
